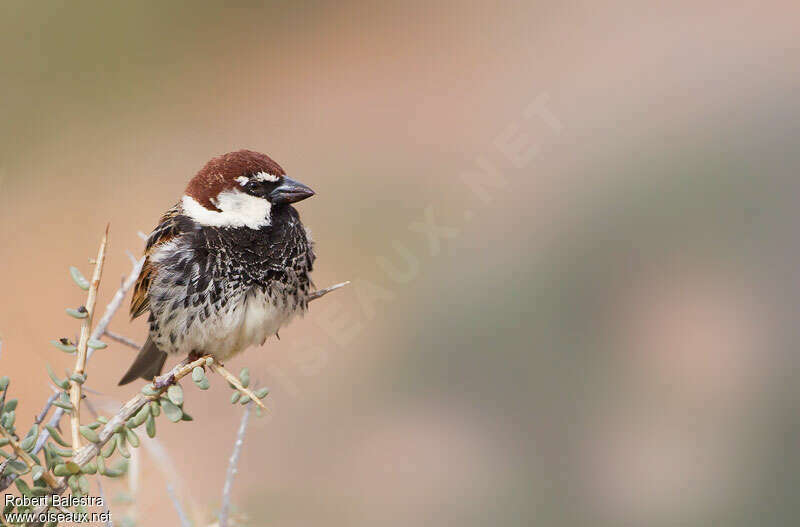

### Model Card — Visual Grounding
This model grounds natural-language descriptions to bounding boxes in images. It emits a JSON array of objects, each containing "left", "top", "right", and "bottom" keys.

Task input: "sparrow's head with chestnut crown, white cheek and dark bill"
[{"left": 182, "top": 150, "right": 314, "bottom": 229}]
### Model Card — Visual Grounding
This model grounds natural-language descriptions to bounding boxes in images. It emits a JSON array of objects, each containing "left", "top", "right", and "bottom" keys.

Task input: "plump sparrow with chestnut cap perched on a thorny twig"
[{"left": 119, "top": 150, "right": 315, "bottom": 385}]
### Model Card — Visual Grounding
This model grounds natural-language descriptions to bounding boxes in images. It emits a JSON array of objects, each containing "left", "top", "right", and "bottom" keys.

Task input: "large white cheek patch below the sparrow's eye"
[{"left": 182, "top": 189, "right": 270, "bottom": 229}]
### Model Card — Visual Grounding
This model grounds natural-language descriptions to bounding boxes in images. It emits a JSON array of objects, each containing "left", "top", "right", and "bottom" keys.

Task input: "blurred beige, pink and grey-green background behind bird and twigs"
[{"left": 0, "top": 0, "right": 800, "bottom": 526}]
